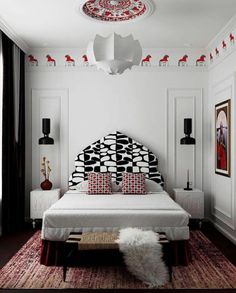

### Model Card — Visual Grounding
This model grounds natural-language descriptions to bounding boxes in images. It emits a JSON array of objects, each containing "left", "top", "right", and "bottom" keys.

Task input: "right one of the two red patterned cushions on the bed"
[{"left": 122, "top": 173, "right": 146, "bottom": 194}]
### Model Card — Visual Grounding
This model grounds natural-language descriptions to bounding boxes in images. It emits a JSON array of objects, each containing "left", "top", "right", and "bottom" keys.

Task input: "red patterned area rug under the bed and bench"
[{"left": 0, "top": 231, "right": 236, "bottom": 289}]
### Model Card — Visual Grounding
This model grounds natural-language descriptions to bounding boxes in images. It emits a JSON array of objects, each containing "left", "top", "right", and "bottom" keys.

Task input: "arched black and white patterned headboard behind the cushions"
[{"left": 69, "top": 131, "right": 164, "bottom": 189}]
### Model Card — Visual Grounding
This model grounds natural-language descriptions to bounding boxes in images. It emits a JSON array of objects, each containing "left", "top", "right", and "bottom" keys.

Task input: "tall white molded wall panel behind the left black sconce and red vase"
[{"left": 32, "top": 89, "right": 69, "bottom": 192}]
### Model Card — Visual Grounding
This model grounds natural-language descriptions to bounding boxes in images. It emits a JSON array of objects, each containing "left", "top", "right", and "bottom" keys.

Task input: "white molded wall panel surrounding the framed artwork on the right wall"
[{"left": 211, "top": 75, "right": 236, "bottom": 230}]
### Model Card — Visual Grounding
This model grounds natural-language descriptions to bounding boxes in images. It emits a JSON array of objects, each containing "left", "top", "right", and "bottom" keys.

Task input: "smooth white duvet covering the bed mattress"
[{"left": 42, "top": 191, "right": 189, "bottom": 241}]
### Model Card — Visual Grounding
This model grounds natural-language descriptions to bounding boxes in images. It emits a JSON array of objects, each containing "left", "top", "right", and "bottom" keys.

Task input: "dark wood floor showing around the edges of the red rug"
[{"left": 0, "top": 223, "right": 236, "bottom": 293}]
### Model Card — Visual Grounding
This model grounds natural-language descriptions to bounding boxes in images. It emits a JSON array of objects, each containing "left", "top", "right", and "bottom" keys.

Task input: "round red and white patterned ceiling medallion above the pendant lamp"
[{"left": 81, "top": 0, "right": 153, "bottom": 22}]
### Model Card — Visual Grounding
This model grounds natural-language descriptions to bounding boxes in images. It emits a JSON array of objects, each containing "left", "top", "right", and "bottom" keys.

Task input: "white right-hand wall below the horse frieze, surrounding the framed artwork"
[{"left": 208, "top": 48, "right": 236, "bottom": 243}]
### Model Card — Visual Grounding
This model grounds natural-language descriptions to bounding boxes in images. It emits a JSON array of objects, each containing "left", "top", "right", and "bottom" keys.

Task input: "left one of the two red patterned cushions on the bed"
[{"left": 88, "top": 172, "right": 112, "bottom": 194}]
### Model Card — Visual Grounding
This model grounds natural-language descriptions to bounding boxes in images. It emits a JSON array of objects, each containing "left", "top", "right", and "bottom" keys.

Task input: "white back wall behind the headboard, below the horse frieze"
[{"left": 26, "top": 48, "right": 207, "bottom": 218}]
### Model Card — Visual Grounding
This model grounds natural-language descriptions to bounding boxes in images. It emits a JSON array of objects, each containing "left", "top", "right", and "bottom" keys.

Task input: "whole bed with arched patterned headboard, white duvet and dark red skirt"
[{"left": 40, "top": 132, "right": 190, "bottom": 265}]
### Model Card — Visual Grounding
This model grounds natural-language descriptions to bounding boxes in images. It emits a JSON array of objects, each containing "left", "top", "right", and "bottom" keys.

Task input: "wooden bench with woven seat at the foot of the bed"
[{"left": 63, "top": 232, "right": 172, "bottom": 281}]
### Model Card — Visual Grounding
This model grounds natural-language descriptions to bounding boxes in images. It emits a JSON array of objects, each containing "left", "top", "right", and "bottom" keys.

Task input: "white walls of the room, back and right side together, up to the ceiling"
[{"left": 23, "top": 17, "right": 236, "bottom": 243}]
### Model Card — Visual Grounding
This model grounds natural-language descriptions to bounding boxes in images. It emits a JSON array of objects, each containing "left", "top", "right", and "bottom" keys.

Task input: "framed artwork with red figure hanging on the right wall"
[{"left": 215, "top": 100, "right": 231, "bottom": 177}]
